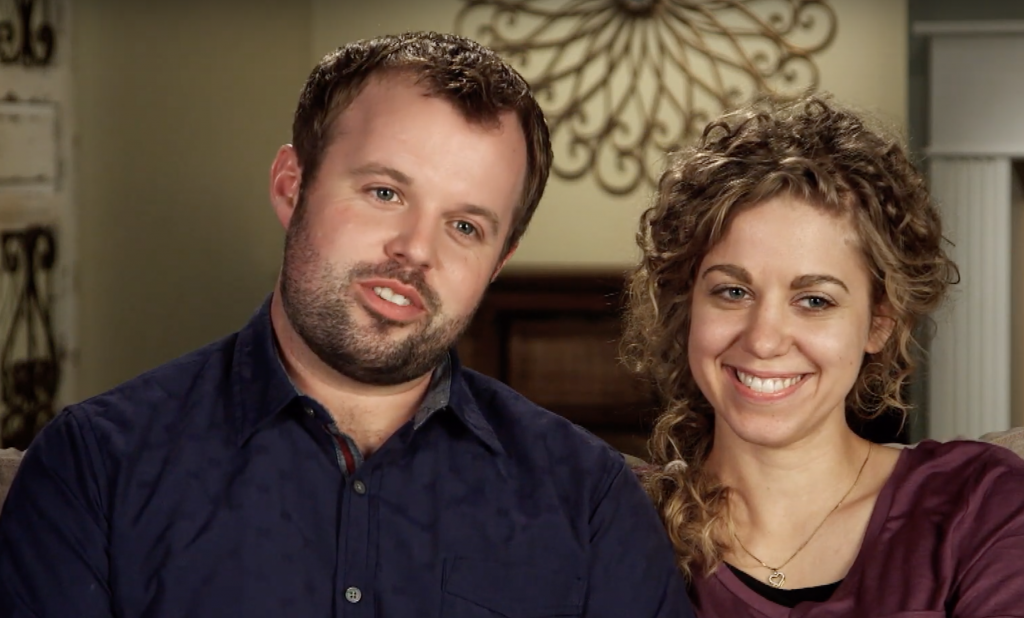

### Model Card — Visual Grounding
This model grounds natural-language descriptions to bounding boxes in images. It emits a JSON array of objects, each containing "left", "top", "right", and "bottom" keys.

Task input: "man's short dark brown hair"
[{"left": 292, "top": 32, "right": 552, "bottom": 253}]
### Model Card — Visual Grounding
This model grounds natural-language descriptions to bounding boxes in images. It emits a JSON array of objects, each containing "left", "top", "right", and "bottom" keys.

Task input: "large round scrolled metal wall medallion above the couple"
[{"left": 456, "top": 0, "right": 837, "bottom": 194}]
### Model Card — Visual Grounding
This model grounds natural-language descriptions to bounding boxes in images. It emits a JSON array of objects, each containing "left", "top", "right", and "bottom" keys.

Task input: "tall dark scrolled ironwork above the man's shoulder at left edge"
[{"left": 0, "top": 226, "right": 60, "bottom": 449}]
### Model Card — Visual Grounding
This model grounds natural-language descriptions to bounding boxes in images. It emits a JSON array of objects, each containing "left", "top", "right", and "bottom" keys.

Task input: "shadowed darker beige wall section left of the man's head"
[{"left": 74, "top": 0, "right": 310, "bottom": 396}]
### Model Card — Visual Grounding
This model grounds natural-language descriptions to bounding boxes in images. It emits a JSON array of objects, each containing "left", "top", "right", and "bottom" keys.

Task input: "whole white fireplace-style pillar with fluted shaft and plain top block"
[{"left": 913, "top": 21, "right": 1024, "bottom": 439}]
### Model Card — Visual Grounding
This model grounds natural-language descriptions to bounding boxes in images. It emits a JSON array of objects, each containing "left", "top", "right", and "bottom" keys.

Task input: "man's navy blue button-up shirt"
[{"left": 0, "top": 305, "right": 691, "bottom": 618}]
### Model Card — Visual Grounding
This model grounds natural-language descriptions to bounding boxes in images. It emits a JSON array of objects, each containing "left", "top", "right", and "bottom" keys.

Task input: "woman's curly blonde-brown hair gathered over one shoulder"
[{"left": 624, "top": 96, "right": 958, "bottom": 578}]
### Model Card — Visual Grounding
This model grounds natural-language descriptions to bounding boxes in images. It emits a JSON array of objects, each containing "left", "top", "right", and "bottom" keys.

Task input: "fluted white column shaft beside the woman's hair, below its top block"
[{"left": 928, "top": 156, "right": 1012, "bottom": 440}]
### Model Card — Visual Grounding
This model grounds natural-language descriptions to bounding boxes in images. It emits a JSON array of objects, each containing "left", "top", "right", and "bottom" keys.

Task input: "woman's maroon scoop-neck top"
[{"left": 691, "top": 440, "right": 1024, "bottom": 618}]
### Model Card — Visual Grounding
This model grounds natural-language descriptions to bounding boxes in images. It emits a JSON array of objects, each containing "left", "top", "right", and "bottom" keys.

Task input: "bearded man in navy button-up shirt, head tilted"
[{"left": 0, "top": 33, "right": 690, "bottom": 618}]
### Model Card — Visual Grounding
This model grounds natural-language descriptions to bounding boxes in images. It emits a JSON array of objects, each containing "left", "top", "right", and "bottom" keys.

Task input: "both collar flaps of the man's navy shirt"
[{"left": 231, "top": 296, "right": 505, "bottom": 453}]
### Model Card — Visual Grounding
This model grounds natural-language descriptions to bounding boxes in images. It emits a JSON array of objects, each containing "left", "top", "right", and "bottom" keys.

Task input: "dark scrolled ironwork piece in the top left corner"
[{"left": 0, "top": 0, "right": 55, "bottom": 67}]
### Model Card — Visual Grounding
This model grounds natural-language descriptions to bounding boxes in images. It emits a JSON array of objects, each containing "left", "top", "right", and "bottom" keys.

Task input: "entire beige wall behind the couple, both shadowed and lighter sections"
[{"left": 73, "top": 0, "right": 906, "bottom": 396}]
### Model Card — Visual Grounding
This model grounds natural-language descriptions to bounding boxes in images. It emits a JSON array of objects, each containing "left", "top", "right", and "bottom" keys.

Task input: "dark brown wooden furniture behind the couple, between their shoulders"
[{"left": 459, "top": 271, "right": 656, "bottom": 457}]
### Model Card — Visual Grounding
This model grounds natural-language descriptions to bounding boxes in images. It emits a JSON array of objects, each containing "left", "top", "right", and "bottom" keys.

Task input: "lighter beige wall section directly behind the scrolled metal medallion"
[{"left": 312, "top": 0, "right": 907, "bottom": 268}]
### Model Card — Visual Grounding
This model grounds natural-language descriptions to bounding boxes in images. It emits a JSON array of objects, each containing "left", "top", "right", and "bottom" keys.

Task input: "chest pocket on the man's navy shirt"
[{"left": 440, "top": 558, "right": 586, "bottom": 618}]
